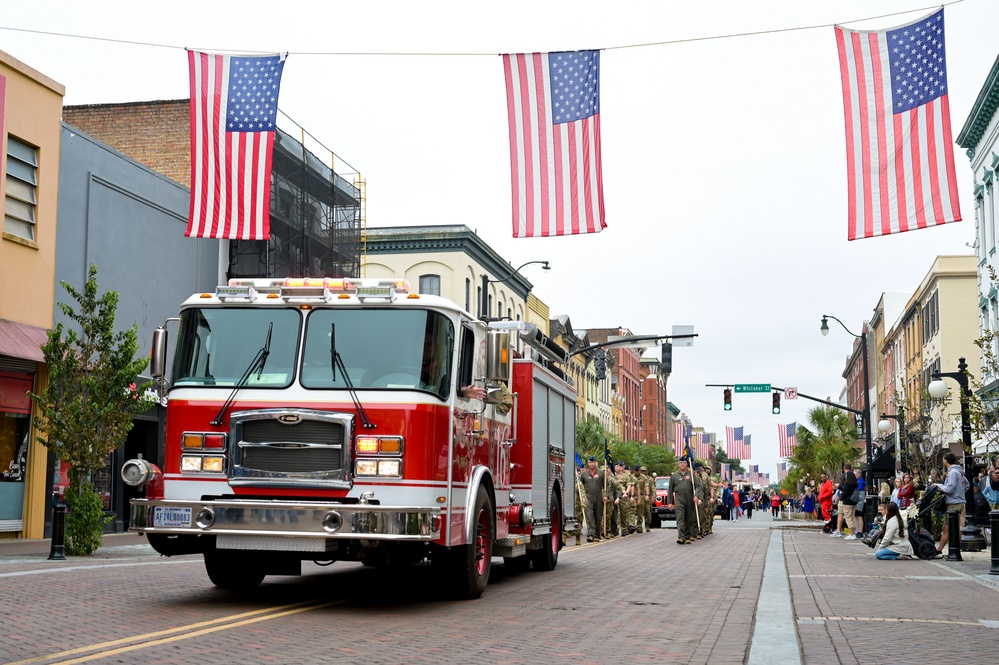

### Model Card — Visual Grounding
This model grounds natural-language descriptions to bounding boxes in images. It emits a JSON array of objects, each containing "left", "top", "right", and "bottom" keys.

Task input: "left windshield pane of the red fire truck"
[{"left": 173, "top": 307, "right": 302, "bottom": 388}]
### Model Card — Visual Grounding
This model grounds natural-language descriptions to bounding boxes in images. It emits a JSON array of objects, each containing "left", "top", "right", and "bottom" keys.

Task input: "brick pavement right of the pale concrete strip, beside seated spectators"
[{"left": 774, "top": 522, "right": 999, "bottom": 663}]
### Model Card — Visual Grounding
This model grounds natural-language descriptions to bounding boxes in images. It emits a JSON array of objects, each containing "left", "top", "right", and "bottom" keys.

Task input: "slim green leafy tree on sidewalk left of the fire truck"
[{"left": 31, "top": 265, "right": 152, "bottom": 556}]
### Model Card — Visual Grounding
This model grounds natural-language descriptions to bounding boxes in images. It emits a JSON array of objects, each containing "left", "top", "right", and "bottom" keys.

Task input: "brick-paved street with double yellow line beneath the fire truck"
[{"left": 0, "top": 514, "right": 999, "bottom": 665}]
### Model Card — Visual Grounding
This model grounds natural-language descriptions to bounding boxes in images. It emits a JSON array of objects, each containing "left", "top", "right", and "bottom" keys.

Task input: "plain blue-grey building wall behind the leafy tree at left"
[{"left": 55, "top": 123, "right": 219, "bottom": 356}]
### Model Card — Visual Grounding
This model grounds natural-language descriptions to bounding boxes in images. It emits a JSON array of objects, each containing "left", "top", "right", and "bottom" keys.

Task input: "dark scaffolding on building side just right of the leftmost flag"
[{"left": 227, "top": 116, "right": 365, "bottom": 278}]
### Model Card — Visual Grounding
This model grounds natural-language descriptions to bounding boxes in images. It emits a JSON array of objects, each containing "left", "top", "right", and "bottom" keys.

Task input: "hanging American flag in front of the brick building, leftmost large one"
[{"left": 184, "top": 51, "right": 285, "bottom": 240}]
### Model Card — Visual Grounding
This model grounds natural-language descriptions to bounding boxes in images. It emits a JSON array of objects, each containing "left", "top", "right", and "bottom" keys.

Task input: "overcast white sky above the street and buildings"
[{"left": 0, "top": 0, "right": 999, "bottom": 477}]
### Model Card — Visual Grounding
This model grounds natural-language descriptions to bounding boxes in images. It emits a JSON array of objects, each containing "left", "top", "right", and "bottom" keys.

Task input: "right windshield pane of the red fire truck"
[{"left": 302, "top": 308, "right": 454, "bottom": 398}]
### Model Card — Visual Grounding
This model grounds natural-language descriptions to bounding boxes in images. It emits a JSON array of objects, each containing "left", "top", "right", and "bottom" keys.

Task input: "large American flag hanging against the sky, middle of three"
[{"left": 503, "top": 51, "right": 607, "bottom": 238}]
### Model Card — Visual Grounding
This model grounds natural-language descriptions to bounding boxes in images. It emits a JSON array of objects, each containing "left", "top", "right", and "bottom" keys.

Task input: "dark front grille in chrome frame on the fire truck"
[{"left": 241, "top": 419, "right": 344, "bottom": 473}]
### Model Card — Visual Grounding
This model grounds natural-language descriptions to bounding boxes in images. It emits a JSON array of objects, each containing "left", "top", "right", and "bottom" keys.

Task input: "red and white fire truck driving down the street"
[{"left": 122, "top": 278, "right": 578, "bottom": 598}]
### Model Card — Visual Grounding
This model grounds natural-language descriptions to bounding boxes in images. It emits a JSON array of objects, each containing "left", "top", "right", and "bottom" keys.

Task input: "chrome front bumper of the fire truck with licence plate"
[{"left": 129, "top": 499, "right": 443, "bottom": 542}]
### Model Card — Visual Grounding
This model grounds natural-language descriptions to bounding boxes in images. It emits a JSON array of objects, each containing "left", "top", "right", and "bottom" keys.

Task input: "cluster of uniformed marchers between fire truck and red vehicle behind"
[{"left": 576, "top": 457, "right": 656, "bottom": 545}]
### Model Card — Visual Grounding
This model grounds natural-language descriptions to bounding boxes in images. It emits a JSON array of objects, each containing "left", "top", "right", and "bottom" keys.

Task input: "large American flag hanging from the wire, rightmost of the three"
[{"left": 836, "top": 8, "right": 961, "bottom": 240}]
